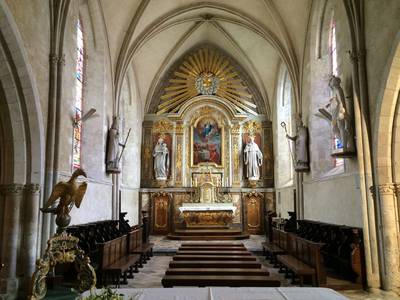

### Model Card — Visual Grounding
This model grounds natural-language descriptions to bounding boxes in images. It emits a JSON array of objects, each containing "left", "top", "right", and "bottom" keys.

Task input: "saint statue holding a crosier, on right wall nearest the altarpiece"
[{"left": 286, "top": 116, "right": 310, "bottom": 172}]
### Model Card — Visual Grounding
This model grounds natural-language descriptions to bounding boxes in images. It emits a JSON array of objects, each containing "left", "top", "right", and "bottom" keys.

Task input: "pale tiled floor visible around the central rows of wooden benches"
[{"left": 127, "top": 236, "right": 400, "bottom": 300}]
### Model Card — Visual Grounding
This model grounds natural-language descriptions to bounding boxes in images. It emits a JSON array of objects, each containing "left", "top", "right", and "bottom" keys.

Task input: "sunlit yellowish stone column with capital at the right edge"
[{"left": 371, "top": 183, "right": 400, "bottom": 291}]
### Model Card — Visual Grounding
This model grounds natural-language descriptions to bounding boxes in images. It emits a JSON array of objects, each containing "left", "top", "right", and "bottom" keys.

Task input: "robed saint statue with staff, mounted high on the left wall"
[{"left": 106, "top": 117, "right": 124, "bottom": 173}]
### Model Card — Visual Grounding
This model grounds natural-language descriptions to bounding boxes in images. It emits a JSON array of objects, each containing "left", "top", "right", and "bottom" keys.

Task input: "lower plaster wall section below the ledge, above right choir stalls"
[{"left": 304, "top": 174, "right": 363, "bottom": 227}]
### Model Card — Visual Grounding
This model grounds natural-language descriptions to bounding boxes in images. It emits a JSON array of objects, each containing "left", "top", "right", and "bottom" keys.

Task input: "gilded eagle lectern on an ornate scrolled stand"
[{"left": 28, "top": 169, "right": 96, "bottom": 300}]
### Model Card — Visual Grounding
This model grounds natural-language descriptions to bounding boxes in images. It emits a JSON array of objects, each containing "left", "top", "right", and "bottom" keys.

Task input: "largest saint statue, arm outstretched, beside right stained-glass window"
[{"left": 318, "top": 75, "right": 355, "bottom": 152}]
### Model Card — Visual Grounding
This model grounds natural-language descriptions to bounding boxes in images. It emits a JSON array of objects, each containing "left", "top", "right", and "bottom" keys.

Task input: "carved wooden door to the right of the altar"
[{"left": 244, "top": 193, "right": 263, "bottom": 234}]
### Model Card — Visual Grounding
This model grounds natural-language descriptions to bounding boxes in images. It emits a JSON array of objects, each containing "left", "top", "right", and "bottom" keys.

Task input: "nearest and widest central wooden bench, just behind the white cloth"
[{"left": 161, "top": 275, "right": 281, "bottom": 287}]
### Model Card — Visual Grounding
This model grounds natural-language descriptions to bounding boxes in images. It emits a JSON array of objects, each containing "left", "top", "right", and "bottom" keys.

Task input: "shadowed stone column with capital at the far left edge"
[{"left": 0, "top": 183, "right": 24, "bottom": 298}]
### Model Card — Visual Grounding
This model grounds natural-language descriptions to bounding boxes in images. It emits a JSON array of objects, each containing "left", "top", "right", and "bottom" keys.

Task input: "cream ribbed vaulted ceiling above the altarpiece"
[{"left": 101, "top": 0, "right": 312, "bottom": 118}]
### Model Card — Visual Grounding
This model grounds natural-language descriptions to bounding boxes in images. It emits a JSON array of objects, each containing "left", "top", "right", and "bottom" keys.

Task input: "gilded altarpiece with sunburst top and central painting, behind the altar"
[{"left": 140, "top": 46, "right": 275, "bottom": 234}]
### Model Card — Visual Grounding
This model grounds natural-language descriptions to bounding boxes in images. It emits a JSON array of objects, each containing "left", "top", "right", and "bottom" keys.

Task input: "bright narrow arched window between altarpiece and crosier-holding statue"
[{"left": 276, "top": 68, "right": 294, "bottom": 187}]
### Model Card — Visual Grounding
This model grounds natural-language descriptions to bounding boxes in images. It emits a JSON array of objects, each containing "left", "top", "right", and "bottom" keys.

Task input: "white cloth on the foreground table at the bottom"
[{"left": 83, "top": 287, "right": 348, "bottom": 300}]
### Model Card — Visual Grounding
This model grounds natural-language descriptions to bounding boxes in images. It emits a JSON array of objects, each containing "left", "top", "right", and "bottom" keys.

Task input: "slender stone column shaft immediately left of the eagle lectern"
[{"left": 23, "top": 184, "right": 40, "bottom": 287}]
